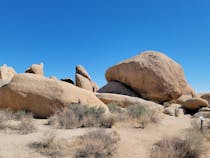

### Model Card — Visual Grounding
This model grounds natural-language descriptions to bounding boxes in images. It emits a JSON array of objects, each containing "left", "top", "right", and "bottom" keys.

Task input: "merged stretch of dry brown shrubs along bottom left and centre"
[{"left": 29, "top": 129, "right": 119, "bottom": 158}]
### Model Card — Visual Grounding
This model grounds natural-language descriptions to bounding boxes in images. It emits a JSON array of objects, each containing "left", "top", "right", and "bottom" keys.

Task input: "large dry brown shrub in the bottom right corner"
[{"left": 150, "top": 130, "right": 206, "bottom": 158}]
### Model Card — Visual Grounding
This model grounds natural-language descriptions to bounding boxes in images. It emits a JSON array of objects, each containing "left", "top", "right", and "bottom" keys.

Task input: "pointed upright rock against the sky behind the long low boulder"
[{"left": 75, "top": 65, "right": 98, "bottom": 92}]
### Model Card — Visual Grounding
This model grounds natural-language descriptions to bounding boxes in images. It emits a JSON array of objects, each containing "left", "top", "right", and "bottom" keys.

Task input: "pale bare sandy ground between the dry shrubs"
[{"left": 0, "top": 115, "right": 210, "bottom": 158}]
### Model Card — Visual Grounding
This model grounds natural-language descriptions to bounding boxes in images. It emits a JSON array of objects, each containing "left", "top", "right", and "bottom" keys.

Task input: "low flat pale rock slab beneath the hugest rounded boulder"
[{"left": 96, "top": 93, "right": 163, "bottom": 112}]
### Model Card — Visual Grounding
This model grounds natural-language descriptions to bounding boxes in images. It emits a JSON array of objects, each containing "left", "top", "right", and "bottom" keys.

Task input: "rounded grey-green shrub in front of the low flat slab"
[{"left": 127, "top": 104, "right": 159, "bottom": 128}]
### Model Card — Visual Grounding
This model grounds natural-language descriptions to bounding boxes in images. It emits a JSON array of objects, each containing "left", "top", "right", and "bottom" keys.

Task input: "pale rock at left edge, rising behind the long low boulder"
[{"left": 0, "top": 64, "right": 16, "bottom": 87}]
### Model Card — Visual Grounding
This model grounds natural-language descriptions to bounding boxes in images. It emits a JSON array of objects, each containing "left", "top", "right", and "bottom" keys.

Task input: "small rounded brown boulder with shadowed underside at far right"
[{"left": 182, "top": 98, "right": 208, "bottom": 110}]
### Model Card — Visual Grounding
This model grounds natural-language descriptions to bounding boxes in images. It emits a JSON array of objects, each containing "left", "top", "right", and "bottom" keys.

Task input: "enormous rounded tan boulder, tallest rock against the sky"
[{"left": 106, "top": 51, "right": 194, "bottom": 103}]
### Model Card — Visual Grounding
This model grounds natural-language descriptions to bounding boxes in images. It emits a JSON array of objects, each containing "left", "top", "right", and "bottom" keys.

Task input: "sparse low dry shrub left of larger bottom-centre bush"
[{"left": 29, "top": 130, "right": 63, "bottom": 158}]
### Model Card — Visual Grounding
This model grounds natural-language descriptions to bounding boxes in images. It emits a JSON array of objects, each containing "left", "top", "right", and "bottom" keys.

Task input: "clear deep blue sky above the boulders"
[{"left": 0, "top": 0, "right": 210, "bottom": 91}]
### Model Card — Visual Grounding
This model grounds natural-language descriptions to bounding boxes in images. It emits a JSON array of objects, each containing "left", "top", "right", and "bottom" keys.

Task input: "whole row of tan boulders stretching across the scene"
[{"left": 0, "top": 51, "right": 210, "bottom": 117}]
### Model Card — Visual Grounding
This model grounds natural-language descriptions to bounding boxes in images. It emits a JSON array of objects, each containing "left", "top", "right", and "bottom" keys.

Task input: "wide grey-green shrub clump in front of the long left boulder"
[{"left": 48, "top": 105, "right": 114, "bottom": 129}]
